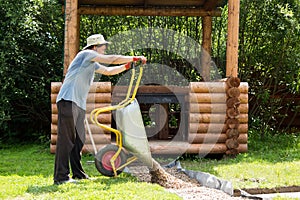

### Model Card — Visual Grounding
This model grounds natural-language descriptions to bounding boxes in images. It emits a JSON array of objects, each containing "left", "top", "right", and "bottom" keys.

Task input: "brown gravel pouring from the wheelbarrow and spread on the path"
[{"left": 128, "top": 160, "right": 245, "bottom": 200}]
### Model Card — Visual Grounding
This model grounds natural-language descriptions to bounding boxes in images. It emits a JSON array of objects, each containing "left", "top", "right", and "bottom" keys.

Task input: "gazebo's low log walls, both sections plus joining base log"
[{"left": 50, "top": 81, "right": 248, "bottom": 155}]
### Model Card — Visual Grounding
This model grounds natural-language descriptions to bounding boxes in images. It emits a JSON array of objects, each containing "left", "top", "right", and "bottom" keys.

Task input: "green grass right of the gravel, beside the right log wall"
[{"left": 181, "top": 131, "right": 300, "bottom": 189}]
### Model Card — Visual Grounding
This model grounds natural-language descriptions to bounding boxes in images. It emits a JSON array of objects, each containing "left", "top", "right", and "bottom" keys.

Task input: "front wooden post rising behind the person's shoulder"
[{"left": 63, "top": 0, "right": 80, "bottom": 76}]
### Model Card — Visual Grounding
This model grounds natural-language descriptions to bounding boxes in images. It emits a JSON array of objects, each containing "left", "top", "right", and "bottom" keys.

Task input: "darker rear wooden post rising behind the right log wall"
[{"left": 201, "top": 16, "right": 212, "bottom": 81}]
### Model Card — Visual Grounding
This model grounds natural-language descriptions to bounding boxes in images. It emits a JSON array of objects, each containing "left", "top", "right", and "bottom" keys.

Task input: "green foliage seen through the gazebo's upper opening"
[{"left": 80, "top": 16, "right": 202, "bottom": 83}]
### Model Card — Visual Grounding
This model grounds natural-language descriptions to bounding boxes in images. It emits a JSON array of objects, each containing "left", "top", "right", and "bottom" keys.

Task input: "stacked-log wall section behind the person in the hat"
[{"left": 50, "top": 82, "right": 111, "bottom": 153}]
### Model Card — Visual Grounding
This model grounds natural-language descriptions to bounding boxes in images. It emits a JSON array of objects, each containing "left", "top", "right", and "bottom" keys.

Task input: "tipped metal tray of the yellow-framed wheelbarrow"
[{"left": 116, "top": 99, "right": 153, "bottom": 168}]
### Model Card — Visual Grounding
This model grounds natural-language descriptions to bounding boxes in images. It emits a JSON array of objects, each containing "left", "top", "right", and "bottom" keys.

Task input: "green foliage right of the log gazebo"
[{"left": 239, "top": 0, "right": 300, "bottom": 129}]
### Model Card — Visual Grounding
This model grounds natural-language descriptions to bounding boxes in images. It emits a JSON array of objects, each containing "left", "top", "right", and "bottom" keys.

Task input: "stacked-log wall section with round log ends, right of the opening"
[{"left": 188, "top": 81, "right": 248, "bottom": 154}]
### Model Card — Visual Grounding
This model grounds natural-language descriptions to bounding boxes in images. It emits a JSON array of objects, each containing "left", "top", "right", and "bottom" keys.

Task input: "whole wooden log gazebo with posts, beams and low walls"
[{"left": 55, "top": 0, "right": 248, "bottom": 155}]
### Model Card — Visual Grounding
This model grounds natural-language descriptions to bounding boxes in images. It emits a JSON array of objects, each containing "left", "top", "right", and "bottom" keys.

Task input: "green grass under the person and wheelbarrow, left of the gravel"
[{"left": 0, "top": 145, "right": 180, "bottom": 200}]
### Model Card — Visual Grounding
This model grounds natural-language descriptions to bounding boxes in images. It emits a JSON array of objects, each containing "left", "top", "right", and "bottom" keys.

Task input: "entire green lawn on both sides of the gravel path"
[{"left": 0, "top": 131, "right": 300, "bottom": 200}]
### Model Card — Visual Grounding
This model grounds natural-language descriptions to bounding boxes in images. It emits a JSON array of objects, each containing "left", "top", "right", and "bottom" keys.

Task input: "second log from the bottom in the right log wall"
[{"left": 188, "top": 133, "right": 248, "bottom": 144}]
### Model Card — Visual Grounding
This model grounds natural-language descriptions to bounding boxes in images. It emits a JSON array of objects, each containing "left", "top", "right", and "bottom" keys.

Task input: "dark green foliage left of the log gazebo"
[{"left": 0, "top": 0, "right": 63, "bottom": 140}]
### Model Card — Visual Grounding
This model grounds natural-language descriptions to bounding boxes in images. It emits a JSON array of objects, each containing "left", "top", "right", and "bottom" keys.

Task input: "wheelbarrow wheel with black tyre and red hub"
[{"left": 95, "top": 144, "right": 127, "bottom": 177}]
